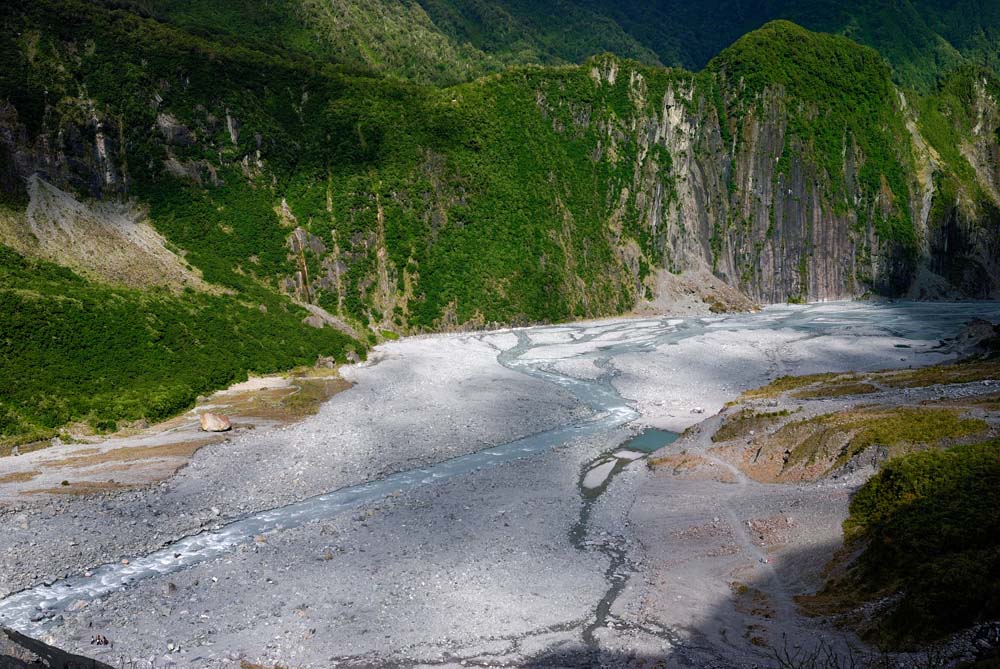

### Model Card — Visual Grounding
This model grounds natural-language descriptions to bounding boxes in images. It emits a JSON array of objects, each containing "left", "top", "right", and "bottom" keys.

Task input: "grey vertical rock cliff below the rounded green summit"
[{"left": 539, "top": 59, "right": 913, "bottom": 303}]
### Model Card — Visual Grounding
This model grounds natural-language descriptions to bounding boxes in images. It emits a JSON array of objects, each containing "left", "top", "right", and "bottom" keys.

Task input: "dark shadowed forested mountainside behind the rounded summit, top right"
[{"left": 440, "top": 0, "right": 1000, "bottom": 90}]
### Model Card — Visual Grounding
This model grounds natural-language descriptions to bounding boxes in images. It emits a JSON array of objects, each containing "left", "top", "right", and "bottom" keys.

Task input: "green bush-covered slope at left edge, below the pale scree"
[{"left": 0, "top": 246, "right": 363, "bottom": 445}]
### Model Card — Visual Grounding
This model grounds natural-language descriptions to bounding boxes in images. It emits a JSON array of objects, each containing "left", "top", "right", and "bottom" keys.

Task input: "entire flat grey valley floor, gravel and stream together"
[{"left": 0, "top": 303, "right": 1000, "bottom": 667}]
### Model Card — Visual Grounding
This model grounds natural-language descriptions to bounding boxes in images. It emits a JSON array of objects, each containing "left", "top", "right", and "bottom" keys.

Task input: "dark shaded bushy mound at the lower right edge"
[{"left": 844, "top": 441, "right": 1000, "bottom": 644}]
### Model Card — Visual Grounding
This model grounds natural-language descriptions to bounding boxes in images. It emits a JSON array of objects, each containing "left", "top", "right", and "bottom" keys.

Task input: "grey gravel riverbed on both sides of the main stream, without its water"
[{"left": 0, "top": 304, "right": 1000, "bottom": 667}]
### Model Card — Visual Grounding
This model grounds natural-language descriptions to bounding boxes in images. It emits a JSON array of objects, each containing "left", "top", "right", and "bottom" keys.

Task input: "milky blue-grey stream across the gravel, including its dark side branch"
[{"left": 0, "top": 303, "right": 1000, "bottom": 645}]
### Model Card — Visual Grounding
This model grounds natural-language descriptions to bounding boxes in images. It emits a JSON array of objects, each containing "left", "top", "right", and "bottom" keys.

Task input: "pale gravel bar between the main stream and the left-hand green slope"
[{"left": 0, "top": 336, "right": 590, "bottom": 595}]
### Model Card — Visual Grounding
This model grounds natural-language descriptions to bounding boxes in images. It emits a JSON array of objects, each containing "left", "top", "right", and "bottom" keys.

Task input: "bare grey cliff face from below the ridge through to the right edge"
[{"left": 556, "top": 51, "right": 1000, "bottom": 303}]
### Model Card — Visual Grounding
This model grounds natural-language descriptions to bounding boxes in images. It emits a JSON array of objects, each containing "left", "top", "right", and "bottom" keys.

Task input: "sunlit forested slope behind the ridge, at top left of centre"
[{"left": 115, "top": 0, "right": 664, "bottom": 85}]
